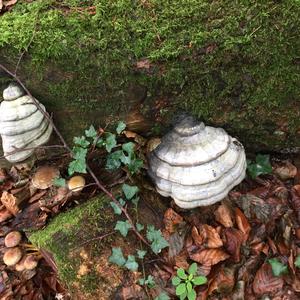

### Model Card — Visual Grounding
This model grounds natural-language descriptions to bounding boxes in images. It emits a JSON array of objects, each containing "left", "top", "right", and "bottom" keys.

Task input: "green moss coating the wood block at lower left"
[{"left": 29, "top": 196, "right": 113, "bottom": 291}]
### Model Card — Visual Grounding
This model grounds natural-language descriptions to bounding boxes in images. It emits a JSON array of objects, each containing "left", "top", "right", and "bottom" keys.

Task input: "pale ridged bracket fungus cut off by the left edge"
[{"left": 0, "top": 83, "right": 53, "bottom": 163}]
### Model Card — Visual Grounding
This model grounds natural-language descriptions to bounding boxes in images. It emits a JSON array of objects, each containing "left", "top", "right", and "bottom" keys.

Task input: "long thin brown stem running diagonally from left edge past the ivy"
[{"left": 0, "top": 64, "right": 150, "bottom": 246}]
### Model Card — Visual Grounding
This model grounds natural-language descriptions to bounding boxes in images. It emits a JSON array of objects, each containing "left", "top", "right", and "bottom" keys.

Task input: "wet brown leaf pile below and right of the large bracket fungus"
[{"left": 144, "top": 161, "right": 300, "bottom": 300}]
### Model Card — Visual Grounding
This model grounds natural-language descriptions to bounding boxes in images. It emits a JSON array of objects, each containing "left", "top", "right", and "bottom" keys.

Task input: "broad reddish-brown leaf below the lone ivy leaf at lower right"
[{"left": 253, "top": 263, "right": 284, "bottom": 295}]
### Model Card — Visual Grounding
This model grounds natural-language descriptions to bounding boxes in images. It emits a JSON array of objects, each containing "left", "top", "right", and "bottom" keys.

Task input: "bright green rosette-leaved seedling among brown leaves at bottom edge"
[{"left": 172, "top": 263, "right": 207, "bottom": 300}]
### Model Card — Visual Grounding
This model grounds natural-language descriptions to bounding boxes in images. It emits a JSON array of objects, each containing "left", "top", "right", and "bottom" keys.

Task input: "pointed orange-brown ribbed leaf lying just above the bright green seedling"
[{"left": 190, "top": 249, "right": 230, "bottom": 266}]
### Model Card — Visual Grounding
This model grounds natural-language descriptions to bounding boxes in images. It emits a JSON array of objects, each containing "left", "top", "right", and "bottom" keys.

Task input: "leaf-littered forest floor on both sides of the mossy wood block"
[{"left": 0, "top": 129, "right": 300, "bottom": 300}]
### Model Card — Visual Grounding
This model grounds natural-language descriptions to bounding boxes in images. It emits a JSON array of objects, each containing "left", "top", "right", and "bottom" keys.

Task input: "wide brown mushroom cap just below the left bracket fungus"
[{"left": 32, "top": 166, "right": 59, "bottom": 190}]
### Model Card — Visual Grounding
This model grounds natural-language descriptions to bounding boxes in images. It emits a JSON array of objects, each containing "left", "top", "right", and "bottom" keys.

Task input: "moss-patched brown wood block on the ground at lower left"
[{"left": 29, "top": 196, "right": 123, "bottom": 300}]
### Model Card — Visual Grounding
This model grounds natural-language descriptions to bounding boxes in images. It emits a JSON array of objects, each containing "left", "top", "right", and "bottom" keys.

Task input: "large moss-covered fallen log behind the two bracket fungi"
[{"left": 0, "top": 0, "right": 300, "bottom": 151}]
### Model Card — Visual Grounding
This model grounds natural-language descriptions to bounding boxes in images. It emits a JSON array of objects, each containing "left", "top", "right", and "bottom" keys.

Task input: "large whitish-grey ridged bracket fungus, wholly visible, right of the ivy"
[{"left": 148, "top": 117, "right": 246, "bottom": 208}]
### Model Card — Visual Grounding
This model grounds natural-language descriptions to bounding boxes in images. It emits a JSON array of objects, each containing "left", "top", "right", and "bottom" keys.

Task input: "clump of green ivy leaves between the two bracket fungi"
[{"left": 68, "top": 122, "right": 143, "bottom": 175}]
